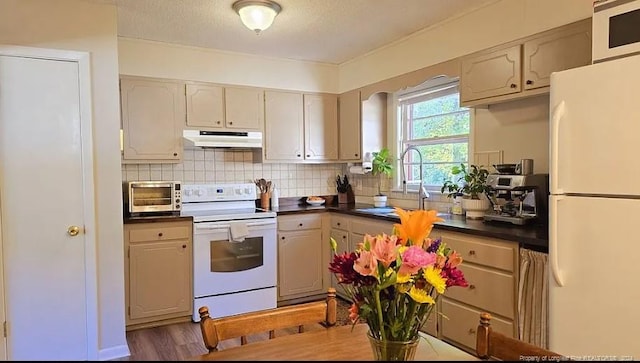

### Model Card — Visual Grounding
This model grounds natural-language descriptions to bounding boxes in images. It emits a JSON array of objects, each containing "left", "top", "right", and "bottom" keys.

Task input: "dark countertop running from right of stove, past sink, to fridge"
[{"left": 273, "top": 203, "right": 549, "bottom": 252}]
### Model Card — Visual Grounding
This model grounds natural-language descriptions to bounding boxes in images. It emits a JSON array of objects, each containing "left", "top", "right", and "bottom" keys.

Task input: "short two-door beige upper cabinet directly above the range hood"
[{"left": 186, "top": 83, "right": 264, "bottom": 131}]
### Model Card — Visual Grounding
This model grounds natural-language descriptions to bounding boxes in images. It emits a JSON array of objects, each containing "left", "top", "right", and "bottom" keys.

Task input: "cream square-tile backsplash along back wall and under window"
[{"left": 122, "top": 148, "right": 451, "bottom": 211}]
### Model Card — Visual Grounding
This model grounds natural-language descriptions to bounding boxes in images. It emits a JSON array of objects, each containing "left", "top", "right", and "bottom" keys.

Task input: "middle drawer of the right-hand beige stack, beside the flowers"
[{"left": 446, "top": 262, "right": 515, "bottom": 319}]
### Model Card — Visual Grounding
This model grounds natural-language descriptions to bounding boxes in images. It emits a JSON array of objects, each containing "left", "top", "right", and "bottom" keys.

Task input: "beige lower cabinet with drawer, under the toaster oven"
[{"left": 124, "top": 221, "right": 193, "bottom": 330}]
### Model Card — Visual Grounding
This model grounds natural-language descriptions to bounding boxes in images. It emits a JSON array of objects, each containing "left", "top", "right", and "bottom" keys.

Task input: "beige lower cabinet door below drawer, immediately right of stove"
[{"left": 278, "top": 229, "right": 326, "bottom": 299}]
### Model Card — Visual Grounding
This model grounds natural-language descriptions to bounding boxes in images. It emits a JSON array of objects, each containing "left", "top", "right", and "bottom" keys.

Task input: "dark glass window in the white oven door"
[{"left": 210, "top": 237, "right": 264, "bottom": 272}]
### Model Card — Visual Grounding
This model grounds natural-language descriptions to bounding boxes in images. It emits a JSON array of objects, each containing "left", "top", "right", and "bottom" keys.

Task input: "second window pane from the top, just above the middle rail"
[{"left": 409, "top": 110, "right": 469, "bottom": 139}]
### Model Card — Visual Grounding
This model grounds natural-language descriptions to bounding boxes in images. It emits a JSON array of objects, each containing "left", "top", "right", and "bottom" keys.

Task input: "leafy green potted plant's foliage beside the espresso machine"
[{"left": 440, "top": 163, "right": 491, "bottom": 199}]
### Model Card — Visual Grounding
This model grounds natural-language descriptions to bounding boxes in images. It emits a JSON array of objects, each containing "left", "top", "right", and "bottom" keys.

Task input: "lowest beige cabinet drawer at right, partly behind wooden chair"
[{"left": 440, "top": 298, "right": 514, "bottom": 350}]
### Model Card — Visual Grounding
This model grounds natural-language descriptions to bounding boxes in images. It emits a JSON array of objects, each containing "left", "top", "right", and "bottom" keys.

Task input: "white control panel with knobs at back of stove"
[{"left": 182, "top": 183, "right": 257, "bottom": 203}]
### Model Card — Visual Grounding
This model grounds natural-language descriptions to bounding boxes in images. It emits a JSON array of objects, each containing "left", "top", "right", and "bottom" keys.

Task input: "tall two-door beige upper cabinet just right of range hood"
[{"left": 264, "top": 90, "right": 338, "bottom": 162}]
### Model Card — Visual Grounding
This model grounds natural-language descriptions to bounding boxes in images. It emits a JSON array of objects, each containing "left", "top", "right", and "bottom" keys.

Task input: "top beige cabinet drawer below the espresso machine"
[{"left": 438, "top": 231, "right": 518, "bottom": 272}]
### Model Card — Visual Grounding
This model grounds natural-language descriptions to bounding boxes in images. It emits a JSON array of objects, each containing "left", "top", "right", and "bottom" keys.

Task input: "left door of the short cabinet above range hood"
[{"left": 186, "top": 84, "right": 224, "bottom": 128}]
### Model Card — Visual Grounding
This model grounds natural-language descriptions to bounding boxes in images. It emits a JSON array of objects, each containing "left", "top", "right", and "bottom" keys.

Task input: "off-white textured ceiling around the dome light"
[{"left": 113, "top": 0, "right": 496, "bottom": 64}]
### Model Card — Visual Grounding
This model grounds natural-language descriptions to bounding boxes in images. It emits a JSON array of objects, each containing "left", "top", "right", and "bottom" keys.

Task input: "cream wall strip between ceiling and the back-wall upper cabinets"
[{"left": 118, "top": 37, "right": 338, "bottom": 93}]
